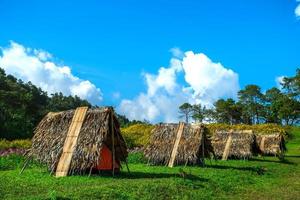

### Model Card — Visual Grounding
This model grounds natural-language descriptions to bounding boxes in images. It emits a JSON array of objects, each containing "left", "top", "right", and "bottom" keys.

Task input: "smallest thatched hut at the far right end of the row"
[{"left": 256, "top": 133, "right": 286, "bottom": 156}]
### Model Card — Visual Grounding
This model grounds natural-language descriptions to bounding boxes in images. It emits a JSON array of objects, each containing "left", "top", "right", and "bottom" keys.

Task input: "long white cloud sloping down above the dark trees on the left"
[{"left": 0, "top": 42, "right": 102, "bottom": 105}]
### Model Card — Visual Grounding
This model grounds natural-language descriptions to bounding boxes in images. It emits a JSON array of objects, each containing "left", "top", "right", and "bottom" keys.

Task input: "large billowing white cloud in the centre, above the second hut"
[{"left": 118, "top": 50, "right": 239, "bottom": 122}]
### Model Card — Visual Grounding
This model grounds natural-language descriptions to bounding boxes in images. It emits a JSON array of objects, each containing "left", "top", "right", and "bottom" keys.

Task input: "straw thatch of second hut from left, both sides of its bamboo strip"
[{"left": 144, "top": 124, "right": 212, "bottom": 165}]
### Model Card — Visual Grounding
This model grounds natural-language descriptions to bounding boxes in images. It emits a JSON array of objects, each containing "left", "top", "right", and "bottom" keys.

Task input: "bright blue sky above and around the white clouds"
[{"left": 0, "top": 0, "right": 300, "bottom": 121}]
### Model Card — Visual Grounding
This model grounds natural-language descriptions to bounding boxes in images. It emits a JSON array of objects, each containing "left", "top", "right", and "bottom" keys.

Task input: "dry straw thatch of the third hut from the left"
[{"left": 211, "top": 130, "right": 255, "bottom": 158}]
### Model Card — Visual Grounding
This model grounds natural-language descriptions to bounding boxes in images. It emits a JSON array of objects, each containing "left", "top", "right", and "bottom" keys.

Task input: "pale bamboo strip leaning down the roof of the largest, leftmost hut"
[{"left": 55, "top": 107, "right": 88, "bottom": 177}]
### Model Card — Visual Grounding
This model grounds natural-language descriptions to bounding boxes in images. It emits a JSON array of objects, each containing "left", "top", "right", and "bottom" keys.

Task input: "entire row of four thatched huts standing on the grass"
[{"left": 27, "top": 107, "right": 285, "bottom": 177}]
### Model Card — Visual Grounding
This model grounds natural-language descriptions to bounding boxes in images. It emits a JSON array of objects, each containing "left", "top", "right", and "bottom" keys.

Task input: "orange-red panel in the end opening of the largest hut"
[{"left": 96, "top": 145, "right": 120, "bottom": 171}]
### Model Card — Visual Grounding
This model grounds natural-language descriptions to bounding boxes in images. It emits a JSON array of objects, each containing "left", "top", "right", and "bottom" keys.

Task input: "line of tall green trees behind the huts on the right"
[{"left": 179, "top": 69, "right": 300, "bottom": 125}]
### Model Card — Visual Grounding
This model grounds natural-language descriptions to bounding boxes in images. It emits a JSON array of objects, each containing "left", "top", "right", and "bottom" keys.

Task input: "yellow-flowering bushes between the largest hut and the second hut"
[{"left": 121, "top": 124, "right": 154, "bottom": 148}]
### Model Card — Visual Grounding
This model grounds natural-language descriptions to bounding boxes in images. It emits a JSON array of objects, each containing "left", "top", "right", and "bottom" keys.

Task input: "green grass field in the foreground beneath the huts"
[{"left": 0, "top": 128, "right": 300, "bottom": 200}]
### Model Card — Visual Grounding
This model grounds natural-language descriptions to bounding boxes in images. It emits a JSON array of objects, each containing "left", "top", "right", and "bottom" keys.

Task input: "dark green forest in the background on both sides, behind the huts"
[{"left": 0, "top": 68, "right": 300, "bottom": 140}]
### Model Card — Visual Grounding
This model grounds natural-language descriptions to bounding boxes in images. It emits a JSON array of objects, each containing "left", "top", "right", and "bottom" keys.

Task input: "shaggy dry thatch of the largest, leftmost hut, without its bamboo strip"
[{"left": 29, "top": 107, "right": 128, "bottom": 173}]
